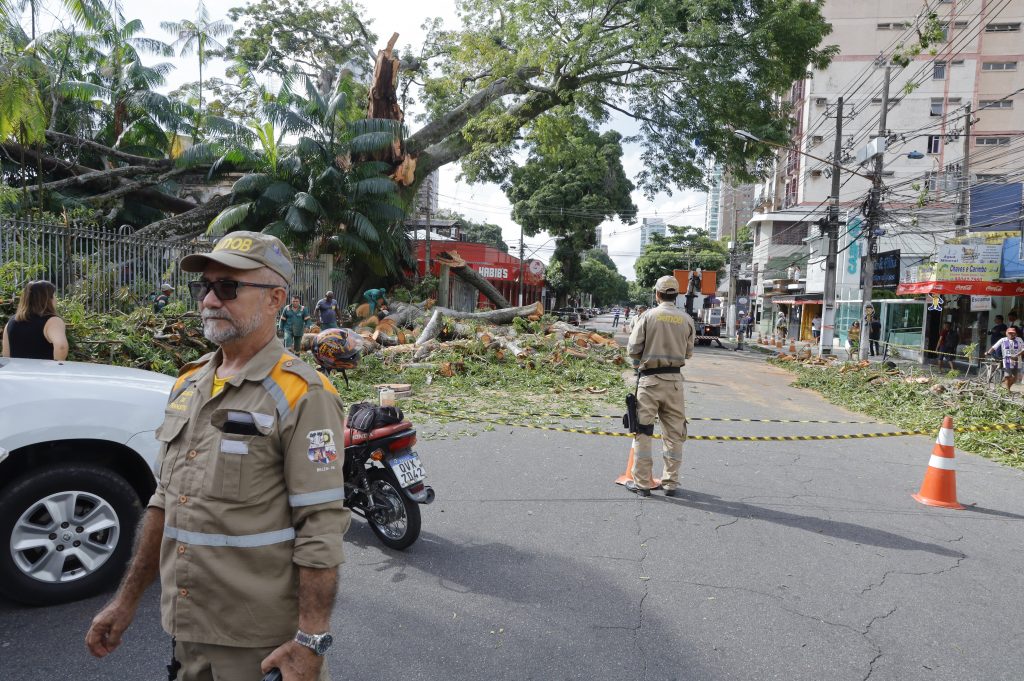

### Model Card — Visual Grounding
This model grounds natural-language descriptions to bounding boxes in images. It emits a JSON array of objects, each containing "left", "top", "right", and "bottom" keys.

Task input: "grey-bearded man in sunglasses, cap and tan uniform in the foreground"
[{"left": 86, "top": 231, "right": 349, "bottom": 681}]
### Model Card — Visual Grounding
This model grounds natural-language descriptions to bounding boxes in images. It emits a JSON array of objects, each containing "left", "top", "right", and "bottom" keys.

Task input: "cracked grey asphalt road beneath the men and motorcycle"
[{"left": 0, "top": 320, "right": 1024, "bottom": 681}]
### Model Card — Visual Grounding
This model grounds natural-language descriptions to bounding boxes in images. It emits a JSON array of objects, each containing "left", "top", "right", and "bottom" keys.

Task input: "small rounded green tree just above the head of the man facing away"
[{"left": 633, "top": 225, "right": 727, "bottom": 290}]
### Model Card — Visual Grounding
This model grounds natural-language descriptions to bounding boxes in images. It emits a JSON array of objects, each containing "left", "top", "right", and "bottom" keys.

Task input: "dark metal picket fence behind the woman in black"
[{"left": 0, "top": 218, "right": 331, "bottom": 312}]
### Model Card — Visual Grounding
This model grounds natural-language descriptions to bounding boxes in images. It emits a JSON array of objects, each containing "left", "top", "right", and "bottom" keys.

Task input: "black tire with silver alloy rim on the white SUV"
[{"left": 0, "top": 465, "right": 142, "bottom": 605}]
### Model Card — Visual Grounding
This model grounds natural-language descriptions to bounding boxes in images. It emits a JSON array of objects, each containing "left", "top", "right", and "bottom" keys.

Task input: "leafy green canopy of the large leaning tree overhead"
[{"left": 424, "top": 0, "right": 838, "bottom": 194}]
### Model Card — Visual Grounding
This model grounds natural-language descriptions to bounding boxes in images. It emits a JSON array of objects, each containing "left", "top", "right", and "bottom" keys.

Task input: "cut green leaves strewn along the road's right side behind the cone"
[{"left": 769, "top": 360, "right": 1024, "bottom": 468}]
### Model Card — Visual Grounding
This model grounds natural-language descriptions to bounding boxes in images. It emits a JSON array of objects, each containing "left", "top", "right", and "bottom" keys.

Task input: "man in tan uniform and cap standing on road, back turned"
[{"left": 626, "top": 274, "right": 696, "bottom": 497}]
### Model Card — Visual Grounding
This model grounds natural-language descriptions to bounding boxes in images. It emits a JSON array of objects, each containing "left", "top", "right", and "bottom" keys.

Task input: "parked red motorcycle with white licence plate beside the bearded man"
[{"left": 343, "top": 411, "right": 434, "bottom": 551}]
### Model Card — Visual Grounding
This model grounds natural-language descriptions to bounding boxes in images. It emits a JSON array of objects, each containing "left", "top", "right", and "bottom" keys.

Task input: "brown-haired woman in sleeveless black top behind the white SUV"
[{"left": 3, "top": 281, "right": 68, "bottom": 359}]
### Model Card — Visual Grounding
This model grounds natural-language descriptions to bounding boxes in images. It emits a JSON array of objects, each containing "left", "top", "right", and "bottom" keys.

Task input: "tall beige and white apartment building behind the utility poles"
[{"left": 749, "top": 0, "right": 1024, "bottom": 333}]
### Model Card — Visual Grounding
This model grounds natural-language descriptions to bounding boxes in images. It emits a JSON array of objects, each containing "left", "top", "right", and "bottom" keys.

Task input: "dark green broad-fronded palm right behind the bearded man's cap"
[{"left": 203, "top": 80, "right": 410, "bottom": 286}]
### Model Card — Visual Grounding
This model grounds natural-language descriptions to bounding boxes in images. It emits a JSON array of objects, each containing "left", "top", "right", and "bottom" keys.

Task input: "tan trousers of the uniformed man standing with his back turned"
[{"left": 632, "top": 374, "right": 686, "bottom": 490}]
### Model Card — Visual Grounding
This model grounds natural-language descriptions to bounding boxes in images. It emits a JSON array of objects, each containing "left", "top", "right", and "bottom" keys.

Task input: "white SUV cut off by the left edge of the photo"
[{"left": 0, "top": 358, "right": 174, "bottom": 605}]
